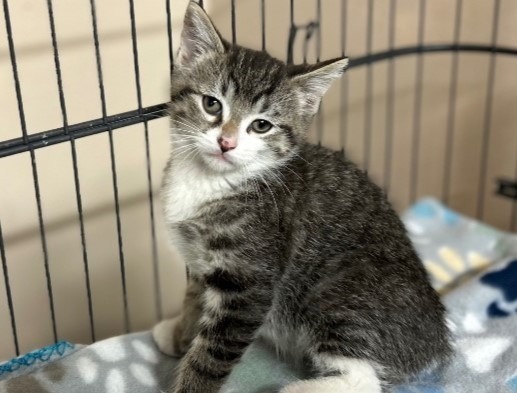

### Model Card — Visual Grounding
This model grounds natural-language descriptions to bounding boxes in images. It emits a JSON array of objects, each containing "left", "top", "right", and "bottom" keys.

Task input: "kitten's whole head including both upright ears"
[{"left": 170, "top": 2, "right": 348, "bottom": 175}]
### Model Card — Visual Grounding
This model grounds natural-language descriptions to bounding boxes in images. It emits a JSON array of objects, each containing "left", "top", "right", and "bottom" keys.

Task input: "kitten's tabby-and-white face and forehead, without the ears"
[{"left": 171, "top": 48, "right": 296, "bottom": 172}]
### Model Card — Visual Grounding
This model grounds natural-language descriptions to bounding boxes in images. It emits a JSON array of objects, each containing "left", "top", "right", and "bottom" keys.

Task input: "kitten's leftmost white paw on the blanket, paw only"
[{"left": 153, "top": 315, "right": 189, "bottom": 357}]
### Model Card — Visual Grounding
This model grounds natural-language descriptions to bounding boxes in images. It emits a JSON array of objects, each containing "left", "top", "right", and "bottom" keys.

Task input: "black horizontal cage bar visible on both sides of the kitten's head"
[{"left": 0, "top": 44, "right": 517, "bottom": 158}]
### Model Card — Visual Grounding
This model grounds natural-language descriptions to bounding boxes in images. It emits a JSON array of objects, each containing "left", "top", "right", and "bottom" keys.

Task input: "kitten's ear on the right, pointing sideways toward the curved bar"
[{"left": 290, "top": 57, "right": 348, "bottom": 115}]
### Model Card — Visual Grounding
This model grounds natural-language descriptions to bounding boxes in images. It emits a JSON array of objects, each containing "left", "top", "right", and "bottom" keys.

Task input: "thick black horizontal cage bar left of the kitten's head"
[{"left": 0, "top": 104, "right": 167, "bottom": 158}]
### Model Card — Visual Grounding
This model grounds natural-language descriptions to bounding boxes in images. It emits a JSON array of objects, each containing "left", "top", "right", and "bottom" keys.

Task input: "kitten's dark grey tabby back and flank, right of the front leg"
[{"left": 270, "top": 144, "right": 450, "bottom": 382}]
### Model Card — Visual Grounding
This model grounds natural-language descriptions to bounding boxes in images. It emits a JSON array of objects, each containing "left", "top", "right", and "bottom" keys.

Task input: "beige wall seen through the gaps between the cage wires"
[{"left": 0, "top": 0, "right": 517, "bottom": 359}]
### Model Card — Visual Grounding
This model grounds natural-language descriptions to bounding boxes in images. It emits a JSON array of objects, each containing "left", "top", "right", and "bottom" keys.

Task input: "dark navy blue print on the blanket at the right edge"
[{"left": 480, "top": 260, "right": 517, "bottom": 318}]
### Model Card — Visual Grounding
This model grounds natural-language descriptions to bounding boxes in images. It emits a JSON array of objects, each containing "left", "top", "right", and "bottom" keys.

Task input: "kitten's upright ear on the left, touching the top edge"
[{"left": 176, "top": 1, "right": 224, "bottom": 66}]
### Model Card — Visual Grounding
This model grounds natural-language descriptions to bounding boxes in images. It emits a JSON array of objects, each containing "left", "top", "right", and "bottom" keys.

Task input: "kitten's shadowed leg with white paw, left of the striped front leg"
[{"left": 153, "top": 281, "right": 202, "bottom": 357}]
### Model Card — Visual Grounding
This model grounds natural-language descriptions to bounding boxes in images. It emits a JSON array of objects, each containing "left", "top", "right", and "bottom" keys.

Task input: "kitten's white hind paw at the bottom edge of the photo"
[{"left": 280, "top": 354, "right": 383, "bottom": 393}]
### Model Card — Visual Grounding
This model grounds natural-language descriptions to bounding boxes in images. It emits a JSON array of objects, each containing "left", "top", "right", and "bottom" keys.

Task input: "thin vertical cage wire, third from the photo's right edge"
[{"left": 409, "top": 0, "right": 426, "bottom": 203}]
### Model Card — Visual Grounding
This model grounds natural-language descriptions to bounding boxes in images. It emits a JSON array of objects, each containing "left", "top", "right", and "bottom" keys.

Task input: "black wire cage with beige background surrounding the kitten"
[{"left": 0, "top": 0, "right": 517, "bottom": 359}]
